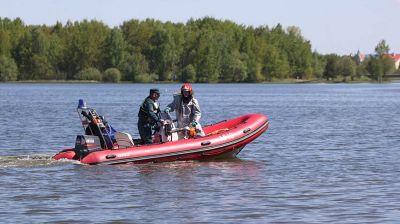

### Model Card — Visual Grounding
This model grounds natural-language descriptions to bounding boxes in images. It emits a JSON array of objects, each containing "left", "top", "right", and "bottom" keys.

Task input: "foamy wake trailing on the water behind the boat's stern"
[{"left": 0, "top": 154, "right": 75, "bottom": 168}]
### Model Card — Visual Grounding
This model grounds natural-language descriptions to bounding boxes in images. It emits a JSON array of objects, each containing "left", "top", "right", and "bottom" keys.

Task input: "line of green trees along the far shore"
[{"left": 0, "top": 17, "right": 394, "bottom": 83}]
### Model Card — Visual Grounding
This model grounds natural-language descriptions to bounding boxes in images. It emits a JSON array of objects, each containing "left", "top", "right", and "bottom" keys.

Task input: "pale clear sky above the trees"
[{"left": 0, "top": 0, "right": 400, "bottom": 55}]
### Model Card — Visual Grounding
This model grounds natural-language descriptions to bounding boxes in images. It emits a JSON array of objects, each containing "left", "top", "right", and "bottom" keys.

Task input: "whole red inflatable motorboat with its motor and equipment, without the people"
[{"left": 53, "top": 100, "right": 269, "bottom": 165}]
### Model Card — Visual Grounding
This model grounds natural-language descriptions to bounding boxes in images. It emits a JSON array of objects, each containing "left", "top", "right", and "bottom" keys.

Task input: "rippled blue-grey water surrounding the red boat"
[{"left": 0, "top": 83, "right": 400, "bottom": 223}]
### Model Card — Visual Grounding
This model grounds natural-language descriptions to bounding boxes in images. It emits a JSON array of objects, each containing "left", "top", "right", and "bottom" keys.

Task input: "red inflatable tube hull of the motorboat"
[{"left": 53, "top": 114, "right": 269, "bottom": 165}]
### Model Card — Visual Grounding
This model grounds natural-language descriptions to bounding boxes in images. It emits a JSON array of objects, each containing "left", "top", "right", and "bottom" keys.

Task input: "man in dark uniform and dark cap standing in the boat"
[{"left": 138, "top": 89, "right": 162, "bottom": 144}]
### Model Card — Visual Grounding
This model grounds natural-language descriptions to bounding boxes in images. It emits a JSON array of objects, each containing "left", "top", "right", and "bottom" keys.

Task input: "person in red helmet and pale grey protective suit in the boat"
[{"left": 164, "top": 83, "right": 205, "bottom": 136}]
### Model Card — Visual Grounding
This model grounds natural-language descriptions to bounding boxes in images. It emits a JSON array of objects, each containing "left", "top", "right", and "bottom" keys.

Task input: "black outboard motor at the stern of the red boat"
[{"left": 74, "top": 135, "right": 102, "bottom": 160}]
